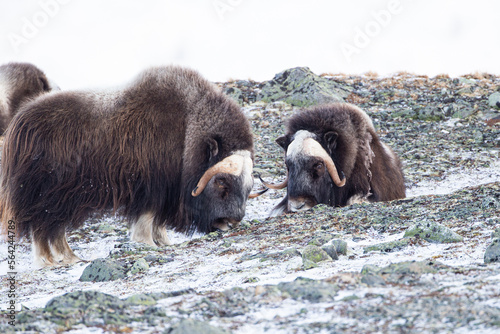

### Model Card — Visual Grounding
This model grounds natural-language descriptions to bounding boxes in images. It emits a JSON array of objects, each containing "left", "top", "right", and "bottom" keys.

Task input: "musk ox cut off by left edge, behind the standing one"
[{"left": 0, "top": 63, "right": 59, "bottom": 134}]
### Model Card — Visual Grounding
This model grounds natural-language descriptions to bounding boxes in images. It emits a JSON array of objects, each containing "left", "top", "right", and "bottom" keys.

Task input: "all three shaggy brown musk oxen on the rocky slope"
[{"left": 0, "top": 63, "right": 405, "bottom": 266}]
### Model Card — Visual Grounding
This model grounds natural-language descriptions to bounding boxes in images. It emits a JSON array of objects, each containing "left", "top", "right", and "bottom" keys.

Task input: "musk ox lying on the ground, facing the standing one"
[{"left": 266, "top": 103, "right": 405, "bottom": 215}]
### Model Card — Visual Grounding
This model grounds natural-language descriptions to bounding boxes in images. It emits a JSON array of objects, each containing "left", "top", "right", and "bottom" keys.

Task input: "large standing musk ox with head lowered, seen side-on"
[{"left": 0, "top": 66, "right": 264, "bottom": 266}]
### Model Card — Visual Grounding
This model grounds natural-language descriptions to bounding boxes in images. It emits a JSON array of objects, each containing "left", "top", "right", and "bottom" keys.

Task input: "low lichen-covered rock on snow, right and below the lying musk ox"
[{"left": 404, "top": 221, "right": 463, "bottom": 244}]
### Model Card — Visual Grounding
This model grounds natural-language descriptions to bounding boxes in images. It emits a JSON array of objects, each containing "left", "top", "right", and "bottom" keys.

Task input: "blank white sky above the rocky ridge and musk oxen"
[{"left": 0, "top": 0, "right": 500, "bottom": 89}]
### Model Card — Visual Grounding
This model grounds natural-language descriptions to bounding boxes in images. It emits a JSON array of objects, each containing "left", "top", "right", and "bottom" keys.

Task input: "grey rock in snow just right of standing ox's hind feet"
[{"left": 80, "top": 259, "right": 127, "bottom": 282}]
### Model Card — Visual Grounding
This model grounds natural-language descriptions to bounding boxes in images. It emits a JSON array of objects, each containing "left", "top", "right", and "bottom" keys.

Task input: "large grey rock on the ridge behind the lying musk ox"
[{"left": 257, "top": 67, "right": 350, "bottom": 107}]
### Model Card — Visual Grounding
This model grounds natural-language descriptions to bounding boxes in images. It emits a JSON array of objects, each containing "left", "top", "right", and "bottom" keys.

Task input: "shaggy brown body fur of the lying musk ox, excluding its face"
[{"left": 276, "top": 103, "right": 405, "bottom": 212}]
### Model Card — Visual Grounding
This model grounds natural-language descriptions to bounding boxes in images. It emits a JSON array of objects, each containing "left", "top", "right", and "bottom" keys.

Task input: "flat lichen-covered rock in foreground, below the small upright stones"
[{"left": 278, "top": 277, "right": 339, "bottom": 303}]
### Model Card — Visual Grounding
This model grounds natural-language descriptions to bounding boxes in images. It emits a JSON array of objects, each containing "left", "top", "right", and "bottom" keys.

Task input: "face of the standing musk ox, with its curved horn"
[{"left": 190, "top": 149, "right": 253, "bottom": 233}]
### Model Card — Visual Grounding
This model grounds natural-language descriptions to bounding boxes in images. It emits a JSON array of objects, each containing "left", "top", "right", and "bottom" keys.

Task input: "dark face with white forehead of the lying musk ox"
[{"left": 277, "top": 130, "right": 345, "bottom": 212}]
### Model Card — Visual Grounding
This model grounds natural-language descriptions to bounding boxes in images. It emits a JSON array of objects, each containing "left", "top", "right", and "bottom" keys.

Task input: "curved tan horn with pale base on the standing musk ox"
[{"left": 191, "top": 152, "right": 252, "bottom": 197}]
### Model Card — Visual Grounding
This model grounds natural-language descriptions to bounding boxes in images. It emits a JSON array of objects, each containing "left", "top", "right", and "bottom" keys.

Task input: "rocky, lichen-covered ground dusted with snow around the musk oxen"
[{"left": 0, "top": 69, "right": 500, "bottom": 333}]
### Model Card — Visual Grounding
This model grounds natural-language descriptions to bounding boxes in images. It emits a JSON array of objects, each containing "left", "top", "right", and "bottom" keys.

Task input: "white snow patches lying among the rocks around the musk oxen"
[{"left": 0, "top": 162, "right": 500, "bottom": 312}]
